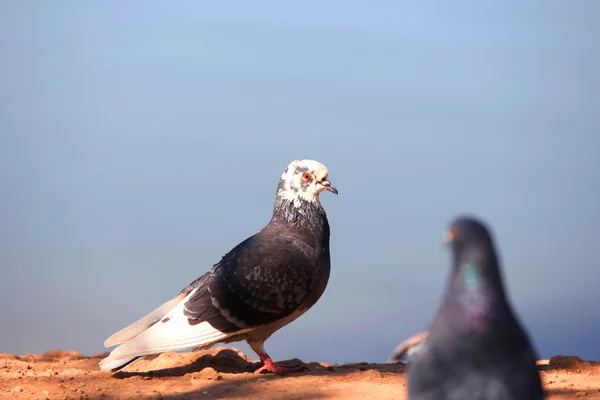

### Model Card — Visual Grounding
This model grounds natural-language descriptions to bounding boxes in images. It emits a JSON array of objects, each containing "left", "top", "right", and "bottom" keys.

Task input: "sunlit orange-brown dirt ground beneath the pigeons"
[{"left": 0, "top": 347, "right": 600, "bottom": 400}]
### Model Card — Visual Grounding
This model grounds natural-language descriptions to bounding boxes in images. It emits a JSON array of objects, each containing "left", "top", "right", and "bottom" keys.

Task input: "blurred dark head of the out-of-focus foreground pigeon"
[{"left": 444, "top": 216, "right": 495, "bottom": 268}]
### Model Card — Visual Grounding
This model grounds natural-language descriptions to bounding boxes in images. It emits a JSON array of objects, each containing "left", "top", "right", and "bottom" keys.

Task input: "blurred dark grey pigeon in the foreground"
[{"left": 408, "top": 216, "right": 544, "bottom": 400}]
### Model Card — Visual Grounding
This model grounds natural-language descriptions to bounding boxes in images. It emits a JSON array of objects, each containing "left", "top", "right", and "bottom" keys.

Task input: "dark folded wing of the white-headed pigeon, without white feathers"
[{"left": 183, "top": 234, "right": 320, "bottom": 330}]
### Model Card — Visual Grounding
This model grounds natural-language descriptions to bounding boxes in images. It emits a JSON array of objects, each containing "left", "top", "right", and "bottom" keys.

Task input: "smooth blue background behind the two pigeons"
[{"left": 0, "top": 0, "right": 600, "bottom": 362}]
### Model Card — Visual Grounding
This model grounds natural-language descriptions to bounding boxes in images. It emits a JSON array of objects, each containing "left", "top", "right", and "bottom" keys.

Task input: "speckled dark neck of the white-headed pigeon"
[{"left": 271, "top": 196, "right": 329, "bottom": 244}]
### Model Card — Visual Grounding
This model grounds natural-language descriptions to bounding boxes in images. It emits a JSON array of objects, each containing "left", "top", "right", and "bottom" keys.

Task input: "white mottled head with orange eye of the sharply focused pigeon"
[{"left": 277, "top": 160, "right": 338, "bottom": 207}]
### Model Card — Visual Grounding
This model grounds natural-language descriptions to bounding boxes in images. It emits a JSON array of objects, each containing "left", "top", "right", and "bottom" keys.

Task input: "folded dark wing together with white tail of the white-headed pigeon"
[{"left": 100, "top": 234, "right": 319, "bottom": 369}]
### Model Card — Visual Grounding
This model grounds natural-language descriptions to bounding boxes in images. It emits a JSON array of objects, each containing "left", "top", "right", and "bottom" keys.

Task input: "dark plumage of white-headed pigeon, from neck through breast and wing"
[{"left": 184, "top": 198, "right": 330, "bottom": 332}]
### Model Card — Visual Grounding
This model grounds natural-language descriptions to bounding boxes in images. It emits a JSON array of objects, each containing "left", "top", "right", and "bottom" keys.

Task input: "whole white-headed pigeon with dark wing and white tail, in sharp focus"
[{"left": 100, "top": 160, "right": 338, "bottom": 375}]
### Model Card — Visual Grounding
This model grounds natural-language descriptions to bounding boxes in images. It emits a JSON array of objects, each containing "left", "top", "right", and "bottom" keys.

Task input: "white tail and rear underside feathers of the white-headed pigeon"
[{"left": 100, "top": 291, "right": 251, "bottom": 370}]
